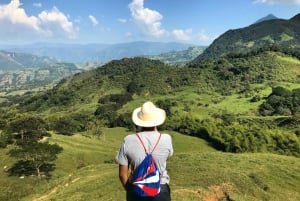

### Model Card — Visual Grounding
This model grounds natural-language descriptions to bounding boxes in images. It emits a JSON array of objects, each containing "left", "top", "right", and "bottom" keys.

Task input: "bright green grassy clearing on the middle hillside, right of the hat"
[{"left": 137, "top": 87, "right": 264, "bottom": 119}]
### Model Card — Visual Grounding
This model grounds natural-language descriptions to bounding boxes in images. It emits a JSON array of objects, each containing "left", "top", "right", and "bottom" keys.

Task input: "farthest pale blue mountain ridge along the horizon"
[{"left": 6, "top": 41, "right": 194, "bottom": 63}]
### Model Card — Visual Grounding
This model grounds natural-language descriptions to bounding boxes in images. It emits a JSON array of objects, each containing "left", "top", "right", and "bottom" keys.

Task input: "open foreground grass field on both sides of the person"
[{"left": 0, "top": 128, "right": 300, "bottom": 201}]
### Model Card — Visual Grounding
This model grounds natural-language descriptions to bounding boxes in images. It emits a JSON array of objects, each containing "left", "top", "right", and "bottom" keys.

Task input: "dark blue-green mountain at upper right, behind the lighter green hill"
[{"left": 193, "top": 14, "right": 300, "bottom": 62}]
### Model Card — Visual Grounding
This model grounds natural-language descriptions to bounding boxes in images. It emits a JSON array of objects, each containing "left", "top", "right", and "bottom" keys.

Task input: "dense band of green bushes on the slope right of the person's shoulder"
[{"left": 164, "top": 114, "right": 300, "bottom": 156}]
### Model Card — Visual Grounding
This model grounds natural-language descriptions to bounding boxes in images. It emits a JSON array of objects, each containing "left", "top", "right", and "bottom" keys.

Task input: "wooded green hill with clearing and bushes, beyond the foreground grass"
[{"left": 4, "top": 50, "right": 300, "bottom": 156}]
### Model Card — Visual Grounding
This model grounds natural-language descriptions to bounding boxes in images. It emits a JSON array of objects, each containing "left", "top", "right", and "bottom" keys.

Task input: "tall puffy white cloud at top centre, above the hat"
[{"left": 129, "top": 0, "right": 166, "bottom": 37}]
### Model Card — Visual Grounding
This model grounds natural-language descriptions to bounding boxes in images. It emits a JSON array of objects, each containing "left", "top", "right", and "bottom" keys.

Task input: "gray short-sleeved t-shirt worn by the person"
[{"left": 115, "top": 131, "right": 173, "bottom": 184}]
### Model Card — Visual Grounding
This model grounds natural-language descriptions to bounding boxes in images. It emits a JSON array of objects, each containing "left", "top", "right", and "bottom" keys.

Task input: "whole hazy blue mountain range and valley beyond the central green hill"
[{"left": 0, "top": 42, "right": 205, "bottom": 89}]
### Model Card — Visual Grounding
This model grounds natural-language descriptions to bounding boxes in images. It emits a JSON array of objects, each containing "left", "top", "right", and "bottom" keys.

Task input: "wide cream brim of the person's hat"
[{"left": 132, "top": 107, "right": 166, "bottom": 127}]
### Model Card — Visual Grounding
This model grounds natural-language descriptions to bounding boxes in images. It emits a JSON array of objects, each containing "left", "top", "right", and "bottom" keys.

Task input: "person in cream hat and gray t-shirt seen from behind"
[{"left": 115, "top": 101, "right": 173, "bottom": 201}]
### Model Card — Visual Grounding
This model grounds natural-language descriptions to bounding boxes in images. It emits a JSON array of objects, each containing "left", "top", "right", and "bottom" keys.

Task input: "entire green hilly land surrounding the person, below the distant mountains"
[{"left": 0, "top": 48, "right": 300, "bottom": 201}]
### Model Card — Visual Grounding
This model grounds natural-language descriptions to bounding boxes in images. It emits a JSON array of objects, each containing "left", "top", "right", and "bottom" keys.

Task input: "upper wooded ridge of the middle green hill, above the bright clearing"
[{"left": 18, "top": 50, "right": 300, "bottom": 111}]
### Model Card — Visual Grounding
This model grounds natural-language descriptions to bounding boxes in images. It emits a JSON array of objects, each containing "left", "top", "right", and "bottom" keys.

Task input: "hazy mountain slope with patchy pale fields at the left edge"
[{"left": 0, "top": 51, "right": 84, "bottom": 90}]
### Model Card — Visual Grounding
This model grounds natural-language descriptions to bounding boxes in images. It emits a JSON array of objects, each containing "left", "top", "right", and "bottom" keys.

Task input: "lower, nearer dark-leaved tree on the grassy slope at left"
[{"left": 9, "top": 141, "right": 62, "bottom": 177}]
